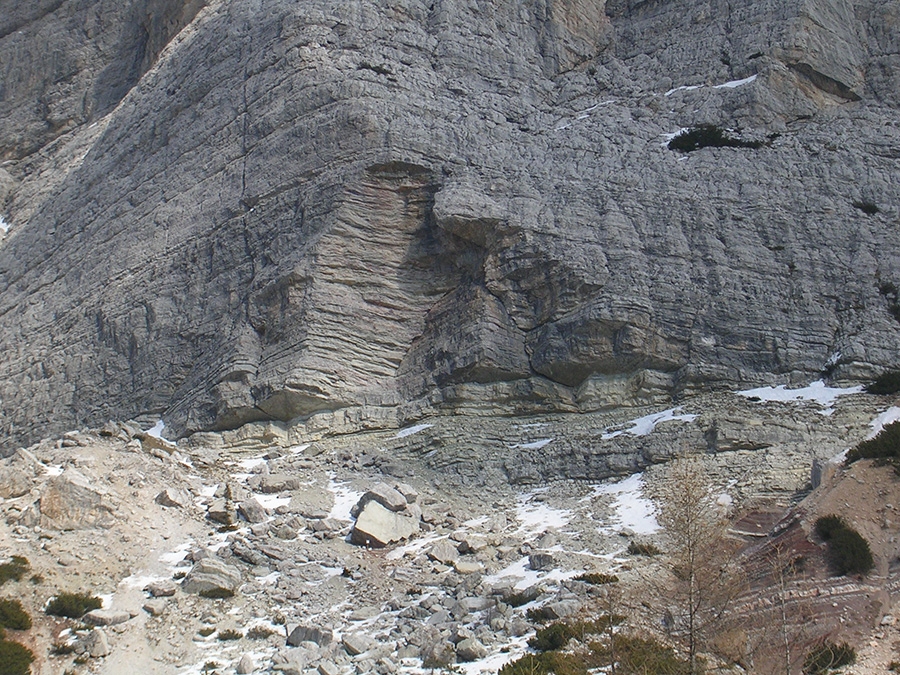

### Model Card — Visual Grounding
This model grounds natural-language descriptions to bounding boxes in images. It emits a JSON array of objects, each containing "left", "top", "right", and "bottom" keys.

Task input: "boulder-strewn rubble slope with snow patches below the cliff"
[{"left": 0, "top": 390, "right": 900, "bottom": 675}]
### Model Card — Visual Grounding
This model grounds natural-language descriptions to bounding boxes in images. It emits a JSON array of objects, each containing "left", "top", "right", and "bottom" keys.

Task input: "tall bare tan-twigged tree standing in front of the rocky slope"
[{"left": 659, "top": 456, "right": 743, "bottom": 673}]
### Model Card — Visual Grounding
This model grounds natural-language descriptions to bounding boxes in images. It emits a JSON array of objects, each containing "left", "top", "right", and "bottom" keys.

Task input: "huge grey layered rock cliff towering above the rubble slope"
[{"left": 0, "top": 0, "right": 900, "bottom": 454}]
